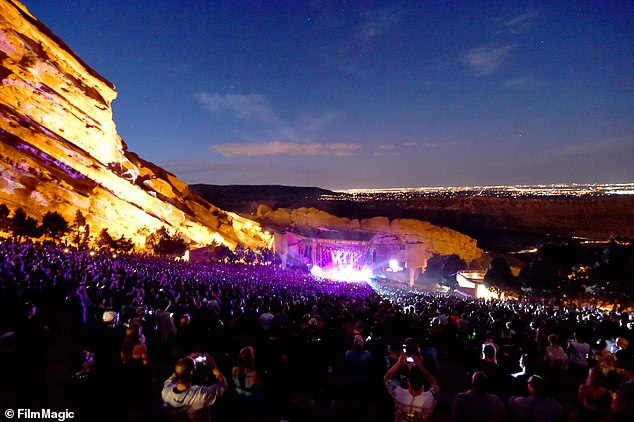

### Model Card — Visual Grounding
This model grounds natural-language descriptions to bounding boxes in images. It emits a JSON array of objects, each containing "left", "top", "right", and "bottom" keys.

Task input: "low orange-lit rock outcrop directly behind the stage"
[{"left": 257, "top": 205, "right": 483, "bottom": 263}]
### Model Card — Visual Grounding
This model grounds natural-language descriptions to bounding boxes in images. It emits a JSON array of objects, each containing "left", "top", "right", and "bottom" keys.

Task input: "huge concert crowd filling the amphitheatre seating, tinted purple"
[{"left": 0, "top": 239, "right": 634, "bottom": 422}]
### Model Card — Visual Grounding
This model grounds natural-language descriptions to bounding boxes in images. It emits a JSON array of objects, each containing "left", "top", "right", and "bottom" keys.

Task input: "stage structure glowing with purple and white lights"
[{"left": 273, "top": 227, "right": 431, "bottom": 286}]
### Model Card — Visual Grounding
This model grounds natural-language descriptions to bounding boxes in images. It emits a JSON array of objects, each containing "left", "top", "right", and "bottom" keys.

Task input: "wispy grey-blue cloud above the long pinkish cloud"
[{"left": 194, "top": 92, "right": 280, "bottom": 124}]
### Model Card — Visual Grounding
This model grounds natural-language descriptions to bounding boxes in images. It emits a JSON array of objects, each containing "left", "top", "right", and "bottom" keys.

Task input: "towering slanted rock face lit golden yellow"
[{"left": 0, "top": 0, "right": 271, "bottom": 248}]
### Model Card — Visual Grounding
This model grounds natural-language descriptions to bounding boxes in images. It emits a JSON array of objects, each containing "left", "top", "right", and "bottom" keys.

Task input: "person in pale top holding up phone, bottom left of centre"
[{"left": 161, "top": 354, "right": 227, "bottom": 421}]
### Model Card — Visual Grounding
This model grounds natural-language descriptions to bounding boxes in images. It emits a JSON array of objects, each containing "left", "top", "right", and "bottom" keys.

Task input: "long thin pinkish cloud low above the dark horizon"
[{"left": 209, "top": 141, "right": 361, "bottom": 157}]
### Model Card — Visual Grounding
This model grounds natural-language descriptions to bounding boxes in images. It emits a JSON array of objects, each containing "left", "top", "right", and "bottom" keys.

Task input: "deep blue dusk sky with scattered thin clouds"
[{"left": 24, "top": 0, "right": 634, "bottom": 189}]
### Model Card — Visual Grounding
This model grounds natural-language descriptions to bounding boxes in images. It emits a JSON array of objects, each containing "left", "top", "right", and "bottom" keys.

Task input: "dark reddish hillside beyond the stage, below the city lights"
[{"left": 190, "top": 184, "right": 634, "bottom": 250}]
